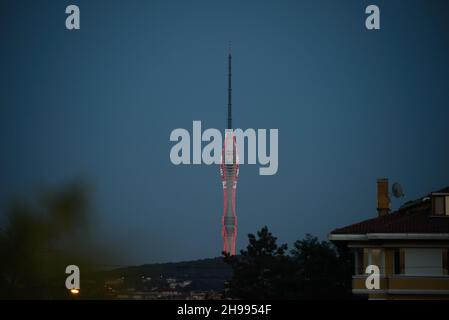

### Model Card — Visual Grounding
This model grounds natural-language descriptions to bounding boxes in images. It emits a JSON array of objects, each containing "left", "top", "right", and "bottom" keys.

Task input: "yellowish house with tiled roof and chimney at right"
[{"left": 329, "top": 179, "right": 449, "bottom": 299}]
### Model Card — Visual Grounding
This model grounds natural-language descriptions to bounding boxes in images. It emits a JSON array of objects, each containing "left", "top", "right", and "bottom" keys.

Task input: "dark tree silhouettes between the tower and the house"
[{"left": 223, "top": 226, "right": 351, "bottom": 299}]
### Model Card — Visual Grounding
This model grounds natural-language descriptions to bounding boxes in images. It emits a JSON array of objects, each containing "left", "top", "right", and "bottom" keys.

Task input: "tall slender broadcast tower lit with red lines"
[{"left": 220, "top": 49, "right": 239, "bottom": 255}]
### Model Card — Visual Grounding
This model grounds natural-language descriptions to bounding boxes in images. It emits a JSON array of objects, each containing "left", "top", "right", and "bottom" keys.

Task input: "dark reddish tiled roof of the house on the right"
[{"left": 331, "top": 187, "right": 449, "bottom": 234}]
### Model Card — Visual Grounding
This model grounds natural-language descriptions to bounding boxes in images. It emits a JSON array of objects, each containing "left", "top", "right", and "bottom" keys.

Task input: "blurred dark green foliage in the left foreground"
[{"left": 0, "top": 182, "right": 108, "bottom": 299}]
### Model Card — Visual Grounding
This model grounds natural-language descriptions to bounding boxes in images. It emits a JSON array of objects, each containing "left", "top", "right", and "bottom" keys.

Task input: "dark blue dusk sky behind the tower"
[{"left": 0, "top": 0, "right": 449, "bottom": 263}]
